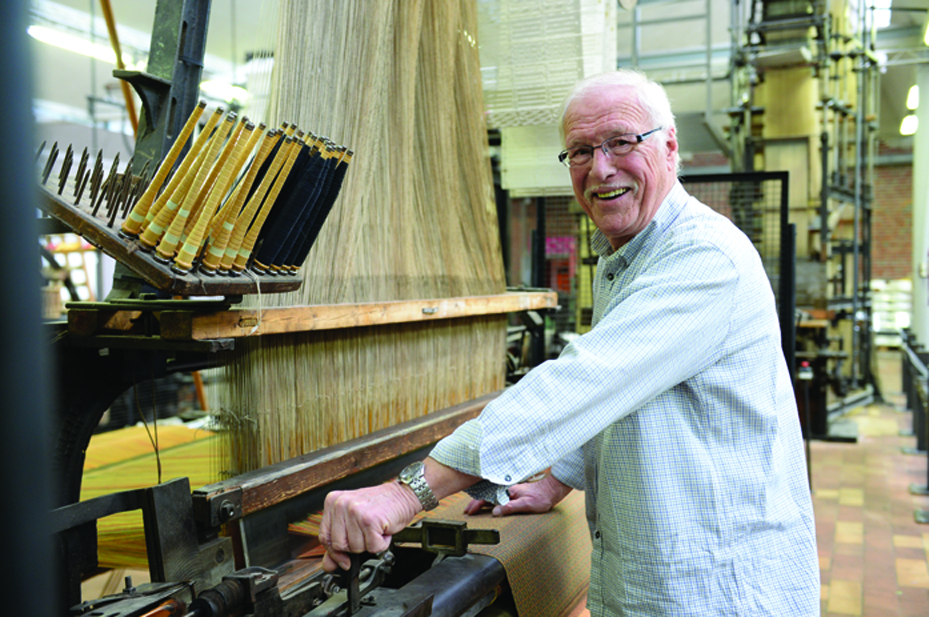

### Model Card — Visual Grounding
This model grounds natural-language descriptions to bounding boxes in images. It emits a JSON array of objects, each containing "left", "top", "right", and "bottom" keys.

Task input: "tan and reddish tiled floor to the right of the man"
[{"left": 810, "top": 351, "right": 929, "bottom": 617}]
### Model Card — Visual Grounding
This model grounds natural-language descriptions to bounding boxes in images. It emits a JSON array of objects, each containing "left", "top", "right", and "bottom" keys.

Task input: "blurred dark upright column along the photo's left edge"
[{"left": 0, "top": 2, "right": 55, "bottom": 615}]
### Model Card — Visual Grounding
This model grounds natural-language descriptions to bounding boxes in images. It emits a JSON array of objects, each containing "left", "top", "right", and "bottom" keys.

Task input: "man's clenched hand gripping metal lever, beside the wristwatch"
[{"left": 319, "top": 482, "right": 422, "bottom": 572}]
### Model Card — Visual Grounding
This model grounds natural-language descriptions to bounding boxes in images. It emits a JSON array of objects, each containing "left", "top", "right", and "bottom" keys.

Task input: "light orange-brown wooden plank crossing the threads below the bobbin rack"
[{"left": 161, "top": 291, "right": 558, "bottom": 340}]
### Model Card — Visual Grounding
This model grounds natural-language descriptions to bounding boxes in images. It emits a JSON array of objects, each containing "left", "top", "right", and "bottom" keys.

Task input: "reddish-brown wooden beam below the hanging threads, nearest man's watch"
[{"left": 193, "top": 390, "right": 502, "bottom": 518}]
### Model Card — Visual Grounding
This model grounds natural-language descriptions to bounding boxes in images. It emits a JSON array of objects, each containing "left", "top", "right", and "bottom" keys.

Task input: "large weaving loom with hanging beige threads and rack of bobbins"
[{"left": 47, "top": 0, "right": 589, "bottom": 616}]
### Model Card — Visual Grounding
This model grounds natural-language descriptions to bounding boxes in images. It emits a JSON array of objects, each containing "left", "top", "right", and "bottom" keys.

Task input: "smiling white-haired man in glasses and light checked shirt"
[{"left": 320, "top": 71, "right": 819, "bottom": 617}]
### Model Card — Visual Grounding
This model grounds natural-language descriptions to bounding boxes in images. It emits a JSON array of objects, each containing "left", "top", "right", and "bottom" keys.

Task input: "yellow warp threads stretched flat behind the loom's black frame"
[{"left": 81, "top": 426, "right": 217, "bottom": 570}]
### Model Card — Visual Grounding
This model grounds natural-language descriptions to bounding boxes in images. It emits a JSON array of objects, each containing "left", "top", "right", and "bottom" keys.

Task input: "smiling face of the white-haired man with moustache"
[{"left": 564, "top": 85, "right": 677, "bottom": 249}]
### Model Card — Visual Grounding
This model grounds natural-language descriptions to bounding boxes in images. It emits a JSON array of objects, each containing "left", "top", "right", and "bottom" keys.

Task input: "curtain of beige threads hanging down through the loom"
[{"left": 220, "top": 0, "right": 506, "bottom": 473}]
